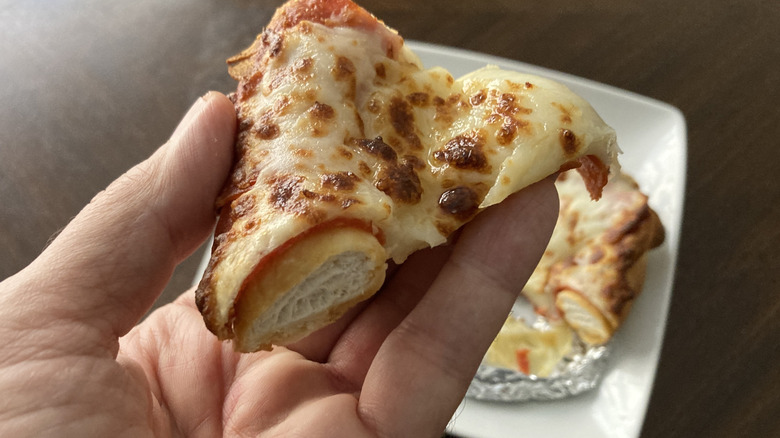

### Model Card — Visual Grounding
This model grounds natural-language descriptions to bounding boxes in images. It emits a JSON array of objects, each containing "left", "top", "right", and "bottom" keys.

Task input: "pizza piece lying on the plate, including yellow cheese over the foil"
[{"left": 485, "top": 171, "right": 665, "bottom": 377}]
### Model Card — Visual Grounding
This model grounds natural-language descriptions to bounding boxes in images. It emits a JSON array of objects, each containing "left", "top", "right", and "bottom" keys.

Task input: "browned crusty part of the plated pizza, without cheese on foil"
[{"left": 522, "top": 172, "right": 665, "bottom": 345}]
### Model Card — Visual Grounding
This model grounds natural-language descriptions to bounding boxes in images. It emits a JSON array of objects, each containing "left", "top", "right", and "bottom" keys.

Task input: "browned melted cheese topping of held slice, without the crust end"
[{"left": 198, "top": 2, "right": 618, "bottom": 337}]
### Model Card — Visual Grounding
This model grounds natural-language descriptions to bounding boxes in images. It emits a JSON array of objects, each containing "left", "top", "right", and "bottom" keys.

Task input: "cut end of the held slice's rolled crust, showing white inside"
[{"left": 234, "top": 226, "right": 387, "bottom": 352}]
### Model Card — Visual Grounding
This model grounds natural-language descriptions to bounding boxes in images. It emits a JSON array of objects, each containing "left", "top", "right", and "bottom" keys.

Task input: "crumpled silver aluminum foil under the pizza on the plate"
[{"left": 466, "top": 324, "right": 610, "bottom": 402}]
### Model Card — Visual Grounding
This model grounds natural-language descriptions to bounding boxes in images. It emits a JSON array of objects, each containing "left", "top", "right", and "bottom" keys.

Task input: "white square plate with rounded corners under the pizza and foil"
[{"left": 408, "top": 42, "right": 687, "bottom": 438}]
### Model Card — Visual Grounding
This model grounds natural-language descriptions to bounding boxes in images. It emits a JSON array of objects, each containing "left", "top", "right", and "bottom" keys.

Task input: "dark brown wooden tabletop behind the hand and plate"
[{"left": 0, "top": 0, "right": 780, "bottom": 438}]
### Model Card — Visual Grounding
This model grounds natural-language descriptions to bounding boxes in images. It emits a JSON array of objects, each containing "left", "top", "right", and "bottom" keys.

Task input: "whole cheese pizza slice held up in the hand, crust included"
[{"left": 196, "top": 0, "right": 618, "bottom": 351}]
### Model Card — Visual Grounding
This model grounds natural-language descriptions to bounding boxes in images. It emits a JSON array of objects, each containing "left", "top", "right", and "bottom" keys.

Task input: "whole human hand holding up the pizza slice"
[{"left": 0, "top": 93, "right": 558, "bottom": 437}]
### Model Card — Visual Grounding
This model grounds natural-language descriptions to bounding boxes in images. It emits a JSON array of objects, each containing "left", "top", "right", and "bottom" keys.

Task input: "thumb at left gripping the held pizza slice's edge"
[{"left": 0, "top": 92, "right": 236, "bottom": 350}]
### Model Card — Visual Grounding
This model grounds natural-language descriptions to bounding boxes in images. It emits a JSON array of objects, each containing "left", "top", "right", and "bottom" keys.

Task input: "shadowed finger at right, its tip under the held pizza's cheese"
[{"left": 359, "top": 179, "right": 558, "bottom": 436}]
